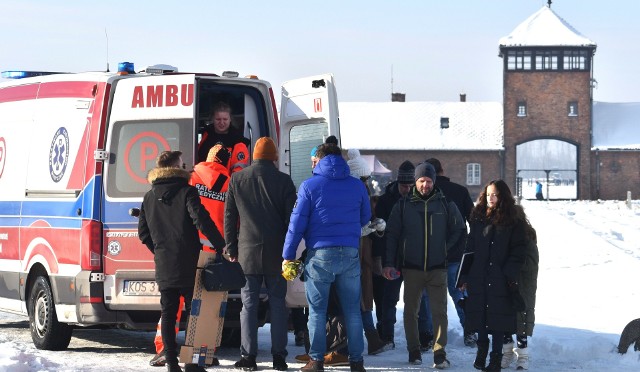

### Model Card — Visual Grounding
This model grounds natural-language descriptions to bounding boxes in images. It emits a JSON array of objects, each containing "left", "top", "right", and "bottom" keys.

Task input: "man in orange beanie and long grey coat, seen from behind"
[{"left": 224, "top": 137, "right": 296, "bottom": 371}]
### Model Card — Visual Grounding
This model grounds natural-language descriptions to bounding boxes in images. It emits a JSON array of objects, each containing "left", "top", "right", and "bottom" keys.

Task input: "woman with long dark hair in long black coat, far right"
[{"left": 462, "top": 180, "right": 530, "bottom": 371}]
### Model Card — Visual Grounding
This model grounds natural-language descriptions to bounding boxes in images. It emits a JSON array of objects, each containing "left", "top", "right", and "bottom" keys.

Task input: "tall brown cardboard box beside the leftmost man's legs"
[{"left": 180, "top": 251, "right": 227, "bottom": 366}]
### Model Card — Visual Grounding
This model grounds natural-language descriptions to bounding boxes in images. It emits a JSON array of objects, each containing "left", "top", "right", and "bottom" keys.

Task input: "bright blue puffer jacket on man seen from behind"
[{"left": 282, "top": 155, "right": 371, "bottom": 260}]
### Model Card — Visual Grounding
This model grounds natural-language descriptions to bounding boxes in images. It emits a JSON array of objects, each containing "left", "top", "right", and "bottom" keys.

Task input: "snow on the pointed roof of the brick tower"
[{"left": 500, "top": 6, "right": 596, "bottom": 47}]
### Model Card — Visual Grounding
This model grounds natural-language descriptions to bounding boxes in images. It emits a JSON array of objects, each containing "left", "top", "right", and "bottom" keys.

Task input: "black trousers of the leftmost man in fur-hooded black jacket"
[{"left": 160, "top": 287, "right": 193, "bottom": 363}]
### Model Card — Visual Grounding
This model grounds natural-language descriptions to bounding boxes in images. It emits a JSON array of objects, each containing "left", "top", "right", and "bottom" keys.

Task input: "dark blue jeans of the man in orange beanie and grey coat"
[{"left": 240, "top": 275, "right": 289, "bottom": 357}]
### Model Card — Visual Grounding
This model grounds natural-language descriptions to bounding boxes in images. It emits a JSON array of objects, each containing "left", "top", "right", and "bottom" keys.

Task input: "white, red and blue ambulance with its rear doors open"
[{"left": 0, "top": 62, "right": 339, "bottom": 350}]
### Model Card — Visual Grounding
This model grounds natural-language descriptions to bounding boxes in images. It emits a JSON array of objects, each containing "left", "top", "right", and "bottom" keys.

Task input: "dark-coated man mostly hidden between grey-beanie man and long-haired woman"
[{"left": 426, "top": 158, "right": 477, "bottom": 347}]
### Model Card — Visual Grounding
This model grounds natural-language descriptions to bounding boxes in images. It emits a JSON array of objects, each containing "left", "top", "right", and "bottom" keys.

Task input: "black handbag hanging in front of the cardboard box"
[{"left": 202, "top": 254, "right": 247, "bottom": 292}]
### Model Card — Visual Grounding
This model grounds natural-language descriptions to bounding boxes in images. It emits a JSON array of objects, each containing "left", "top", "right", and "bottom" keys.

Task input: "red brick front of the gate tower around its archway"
[{"left": 503, "top": 71, "right": 592, "bottom": 199}]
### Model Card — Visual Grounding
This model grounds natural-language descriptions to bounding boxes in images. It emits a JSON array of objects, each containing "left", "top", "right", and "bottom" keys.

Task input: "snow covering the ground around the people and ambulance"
[{"left": 0, "top": 200, "right": 640, "bottom": 372}]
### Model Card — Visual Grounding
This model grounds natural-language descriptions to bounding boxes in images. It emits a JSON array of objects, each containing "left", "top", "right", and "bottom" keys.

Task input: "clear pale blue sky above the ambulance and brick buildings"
[{"left": 0, "top": 0, "right": 640, "bottom": 102}]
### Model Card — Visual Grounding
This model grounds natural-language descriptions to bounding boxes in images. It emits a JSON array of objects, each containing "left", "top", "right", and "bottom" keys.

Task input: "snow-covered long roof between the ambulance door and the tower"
[{"left": 339, "top": 102, "right": 503, "bottom": 150}]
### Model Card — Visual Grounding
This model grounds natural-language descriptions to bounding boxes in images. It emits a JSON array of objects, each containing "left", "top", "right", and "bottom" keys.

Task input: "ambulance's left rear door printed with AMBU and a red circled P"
[{"left": 102, "top": 74, "right": 197, "bottom": 310}]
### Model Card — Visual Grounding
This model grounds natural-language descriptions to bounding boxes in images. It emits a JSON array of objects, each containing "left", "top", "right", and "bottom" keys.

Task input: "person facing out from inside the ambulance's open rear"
[{"left": 196, "top": 102, "right": 251, "bottom": 173}]
